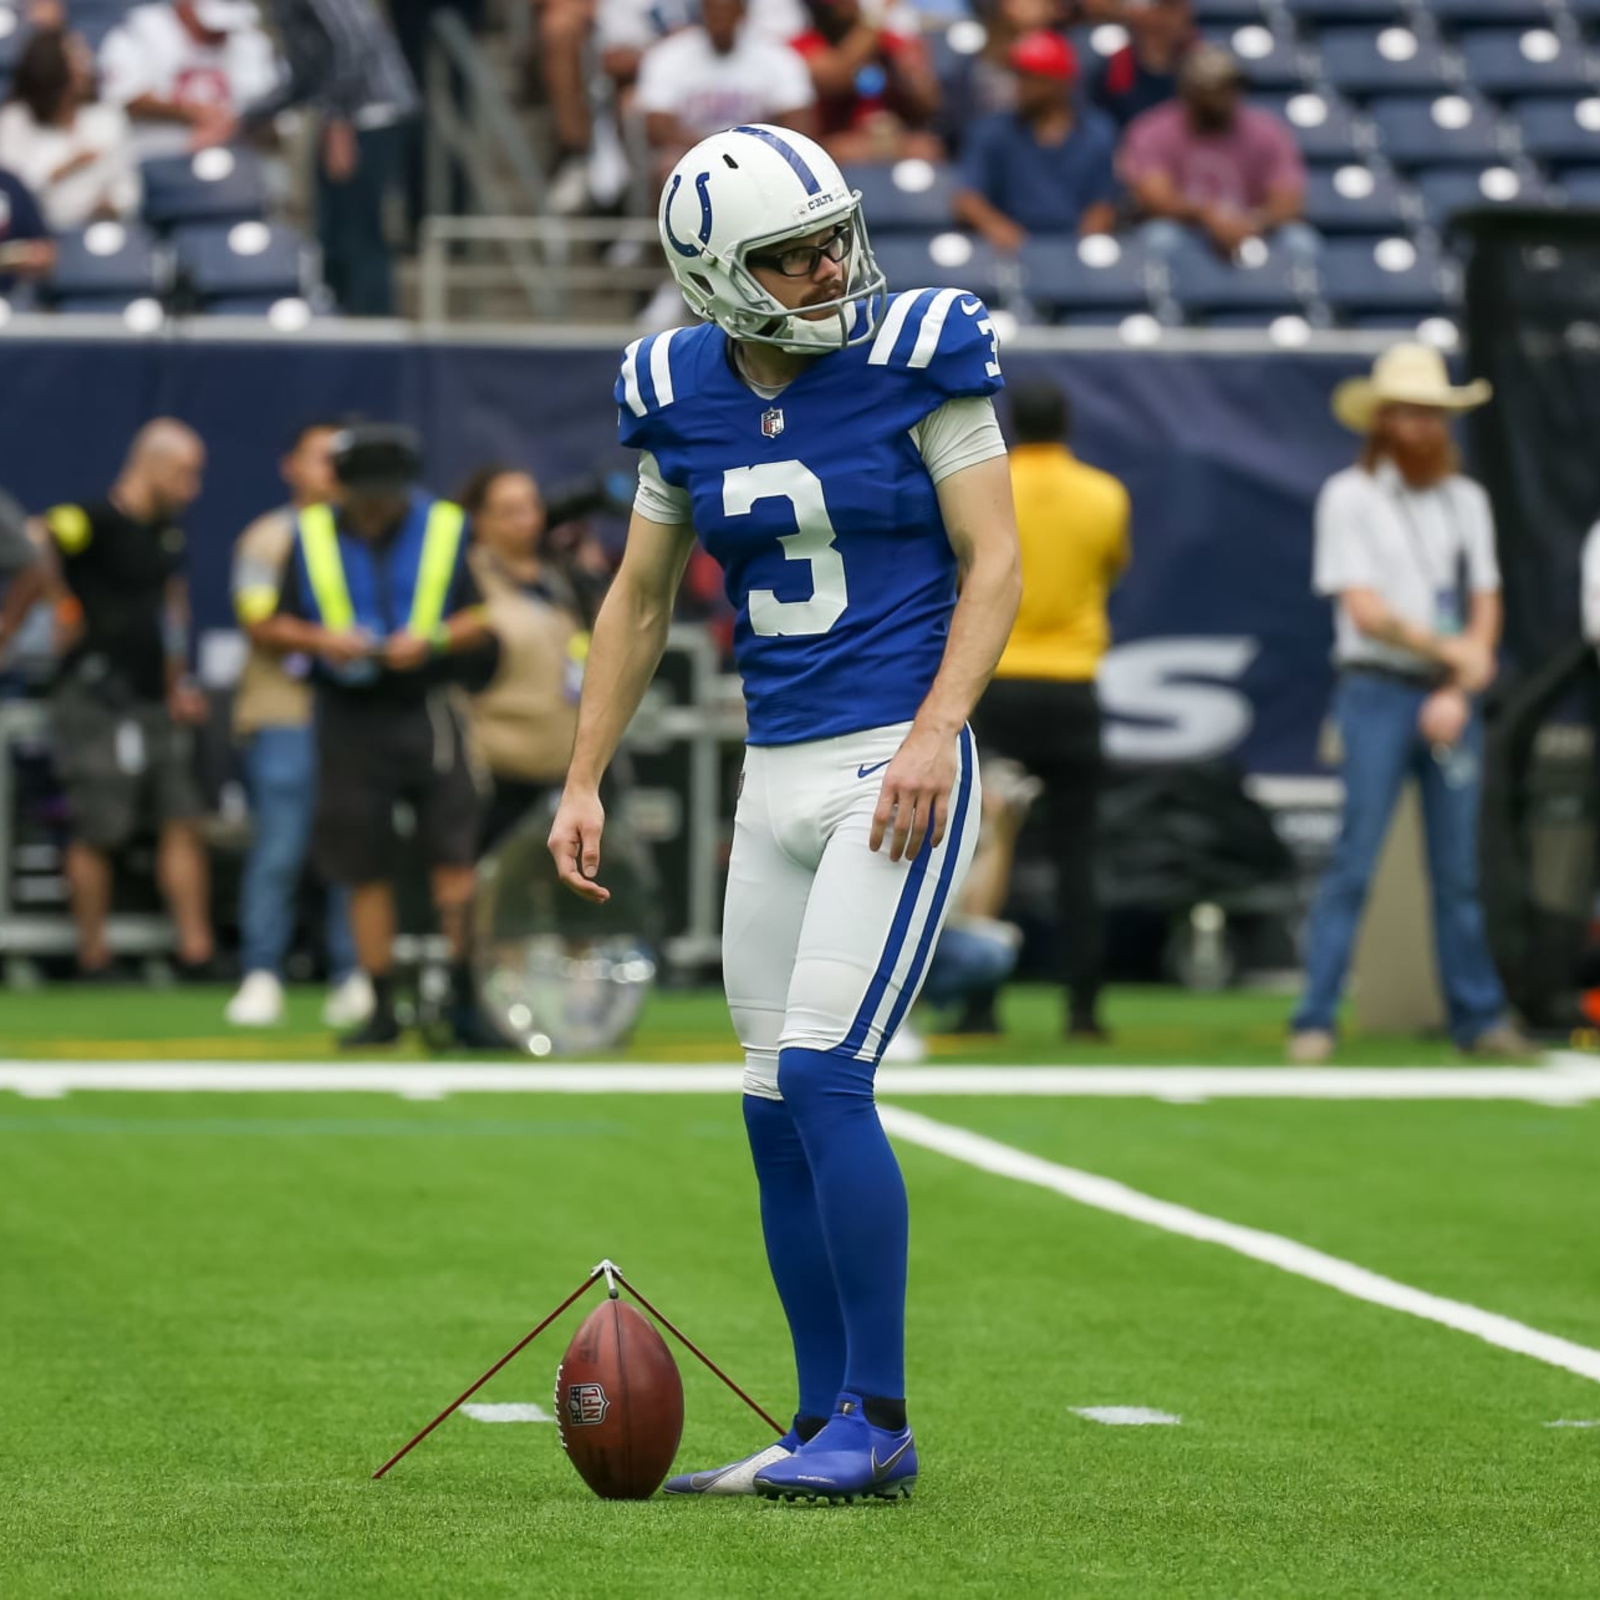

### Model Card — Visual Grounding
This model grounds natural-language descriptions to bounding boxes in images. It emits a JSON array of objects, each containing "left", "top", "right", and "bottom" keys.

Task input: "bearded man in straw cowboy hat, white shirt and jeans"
[{"left": 1290, "top": 344, "right": 1528, "bottom": 1064}]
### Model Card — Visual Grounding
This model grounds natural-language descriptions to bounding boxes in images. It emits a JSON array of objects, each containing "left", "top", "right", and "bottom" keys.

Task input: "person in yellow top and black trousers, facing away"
[{"left": 962, "top": 382, "right": 1130, "bottom": 1040}]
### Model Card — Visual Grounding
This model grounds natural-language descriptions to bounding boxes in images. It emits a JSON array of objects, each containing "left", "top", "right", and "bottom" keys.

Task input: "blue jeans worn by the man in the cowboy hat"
[{"left": 1293, "top": 672, "right": 1506, "bottom": 1045}]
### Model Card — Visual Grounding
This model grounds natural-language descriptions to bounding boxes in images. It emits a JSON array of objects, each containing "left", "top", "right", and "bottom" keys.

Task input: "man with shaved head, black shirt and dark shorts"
[{"left": 35, "top": 418, "right": 213, "bottom": 981}]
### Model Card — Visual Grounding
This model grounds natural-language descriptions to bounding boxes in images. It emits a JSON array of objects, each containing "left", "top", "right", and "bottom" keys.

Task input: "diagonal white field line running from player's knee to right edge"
[{"left": 882, "top": 1106, "right": 1600, "bottom": 1382}]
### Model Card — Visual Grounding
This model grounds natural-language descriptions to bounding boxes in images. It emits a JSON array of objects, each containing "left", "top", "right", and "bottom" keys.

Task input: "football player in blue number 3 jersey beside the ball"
[{"left": 550, "top": 126, "right": 1021, "bottom": 1499}]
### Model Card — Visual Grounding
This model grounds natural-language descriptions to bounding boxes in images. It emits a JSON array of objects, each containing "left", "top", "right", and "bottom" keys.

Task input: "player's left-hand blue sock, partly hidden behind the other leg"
[{"left": 744, "top": 1094, "right": 845, "bottom": 1432}]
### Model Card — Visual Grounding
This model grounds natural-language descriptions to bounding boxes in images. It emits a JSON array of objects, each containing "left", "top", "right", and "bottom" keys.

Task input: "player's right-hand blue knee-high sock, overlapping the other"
[{"left": 778, "top": 1050, "right": 909, "bottom": 1398}]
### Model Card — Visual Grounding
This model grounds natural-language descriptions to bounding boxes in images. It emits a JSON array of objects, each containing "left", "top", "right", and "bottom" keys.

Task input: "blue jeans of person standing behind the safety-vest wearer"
[{"left": 238, "top": 728, "right": 355, "bottom": 982}]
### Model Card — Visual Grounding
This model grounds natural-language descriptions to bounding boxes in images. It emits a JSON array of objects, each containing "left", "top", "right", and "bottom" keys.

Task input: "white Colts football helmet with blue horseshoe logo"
[{"left": 658, "top": 123, "right": 885, "bottom": 355}]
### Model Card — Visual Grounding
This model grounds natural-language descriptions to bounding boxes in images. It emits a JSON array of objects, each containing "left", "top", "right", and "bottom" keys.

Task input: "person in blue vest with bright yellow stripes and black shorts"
[{"left": 258, "top": 424, "right": 499, "bottom": 1048}]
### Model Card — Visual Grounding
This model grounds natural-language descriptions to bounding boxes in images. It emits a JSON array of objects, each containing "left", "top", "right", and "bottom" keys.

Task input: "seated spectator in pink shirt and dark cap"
[{"left": 1122, "top": 45, "right": 1317, "bottom": 259}]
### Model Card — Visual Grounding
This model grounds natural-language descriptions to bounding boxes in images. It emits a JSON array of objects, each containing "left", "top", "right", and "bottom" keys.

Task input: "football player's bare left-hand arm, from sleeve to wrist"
[{"left": 566, "top": 512, "right": 694, "bottom": 790}]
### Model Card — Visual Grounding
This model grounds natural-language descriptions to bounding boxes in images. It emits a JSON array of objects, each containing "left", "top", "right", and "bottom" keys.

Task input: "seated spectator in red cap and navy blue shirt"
[{"left": 955, "top": 29, "right": 1117, "bottom": 254}]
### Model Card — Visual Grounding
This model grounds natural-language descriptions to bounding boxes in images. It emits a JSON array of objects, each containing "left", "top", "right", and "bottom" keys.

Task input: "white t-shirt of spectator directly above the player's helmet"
[{"left": 638, "top": 24, "right": 816, "bottom": 139}]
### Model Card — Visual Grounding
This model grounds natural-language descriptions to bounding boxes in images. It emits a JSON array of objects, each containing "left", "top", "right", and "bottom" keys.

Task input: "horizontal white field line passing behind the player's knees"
[{"left": 0, "top": 1056, "right": 1600, "bottom": 1106}]
